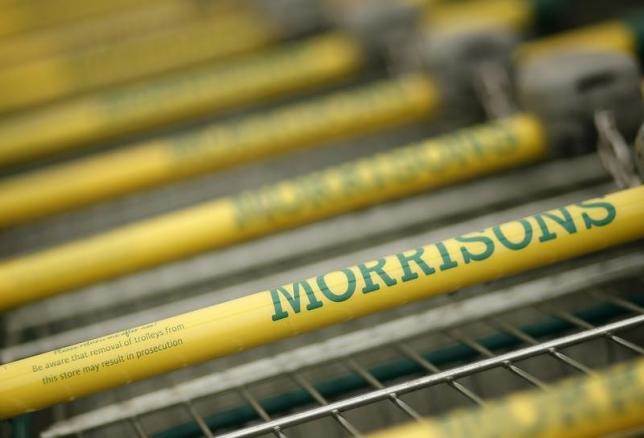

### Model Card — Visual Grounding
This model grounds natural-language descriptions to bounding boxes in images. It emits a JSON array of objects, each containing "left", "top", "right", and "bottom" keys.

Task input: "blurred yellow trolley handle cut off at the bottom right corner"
[{"left": 370, "top": 359, "right": 644, "bottom": 438}]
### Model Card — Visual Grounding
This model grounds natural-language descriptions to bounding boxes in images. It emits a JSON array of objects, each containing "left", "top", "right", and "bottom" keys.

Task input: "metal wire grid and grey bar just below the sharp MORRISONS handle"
[{"left": 34, "top": 250, "right": 644, "bottom": 437}]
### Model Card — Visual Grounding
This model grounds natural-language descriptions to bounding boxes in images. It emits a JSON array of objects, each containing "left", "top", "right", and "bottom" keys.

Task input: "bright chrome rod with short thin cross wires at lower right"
[{"left": 215, "top": 306, "right": 644, "bottom": 438}]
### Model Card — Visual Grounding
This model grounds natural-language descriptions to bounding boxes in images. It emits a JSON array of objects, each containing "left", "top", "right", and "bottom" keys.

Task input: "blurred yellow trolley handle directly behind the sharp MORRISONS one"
[{"left": 0, "top": 112, "right": 547, "bottom": 304}]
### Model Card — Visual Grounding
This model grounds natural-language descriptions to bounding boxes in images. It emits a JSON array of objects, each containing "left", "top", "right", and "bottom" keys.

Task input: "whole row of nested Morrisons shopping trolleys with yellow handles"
[{"left": 0, "top": 0, "right": 644, "bottom": 437}]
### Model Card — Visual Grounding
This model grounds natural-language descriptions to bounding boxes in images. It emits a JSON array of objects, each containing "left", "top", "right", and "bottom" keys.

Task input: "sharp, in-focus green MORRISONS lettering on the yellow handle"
[{"left": 269, "top": 200, "right": 617, "bottom": 321}]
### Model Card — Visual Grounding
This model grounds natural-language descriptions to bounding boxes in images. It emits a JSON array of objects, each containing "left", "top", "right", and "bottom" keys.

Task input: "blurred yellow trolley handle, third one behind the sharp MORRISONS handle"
[{"left": 0, "top": 33, "right": 363, "bottom": 166}]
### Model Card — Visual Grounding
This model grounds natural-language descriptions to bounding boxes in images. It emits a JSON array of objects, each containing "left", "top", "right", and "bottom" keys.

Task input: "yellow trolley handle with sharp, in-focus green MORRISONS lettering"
[{"left": 0, "top": 187, "right": 644, "bottom": 418}]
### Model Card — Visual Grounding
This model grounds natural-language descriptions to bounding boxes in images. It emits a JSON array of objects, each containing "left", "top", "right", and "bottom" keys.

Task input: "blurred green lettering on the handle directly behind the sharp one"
[{"left": 231, "top": 123, "right": 518, "bottom": 229}]
